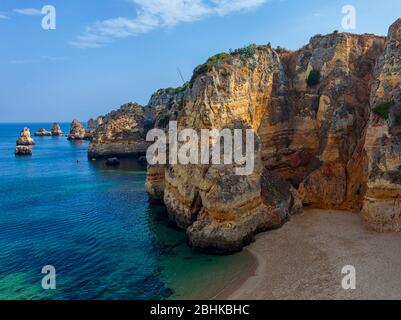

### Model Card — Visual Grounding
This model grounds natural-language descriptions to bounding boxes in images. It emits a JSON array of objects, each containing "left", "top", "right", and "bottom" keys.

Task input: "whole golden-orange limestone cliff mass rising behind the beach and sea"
[{"left": 89, "top": 19, "right": 401, "bottom": 253}]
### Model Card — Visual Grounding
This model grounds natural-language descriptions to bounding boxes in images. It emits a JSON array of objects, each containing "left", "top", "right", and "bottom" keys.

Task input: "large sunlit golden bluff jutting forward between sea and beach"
[{"left": 159, "top": 47, "right": 295, "bottom": 252}]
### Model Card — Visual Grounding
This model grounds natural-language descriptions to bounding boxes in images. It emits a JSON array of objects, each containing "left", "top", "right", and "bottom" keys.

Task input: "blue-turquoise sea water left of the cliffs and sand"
[{"left": 0, "top": 124, "right": 252, "bottom": 300}]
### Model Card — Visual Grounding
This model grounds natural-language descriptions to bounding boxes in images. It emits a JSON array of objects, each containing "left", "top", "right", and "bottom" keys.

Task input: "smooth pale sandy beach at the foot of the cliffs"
[{"left": 223, "top": 210, "right": 401, "bottom": 300}]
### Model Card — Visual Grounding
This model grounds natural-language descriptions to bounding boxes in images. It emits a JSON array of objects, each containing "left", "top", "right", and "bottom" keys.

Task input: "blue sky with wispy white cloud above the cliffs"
[{"left": 0, "top": 0, "right": 401, "bottom": 122}]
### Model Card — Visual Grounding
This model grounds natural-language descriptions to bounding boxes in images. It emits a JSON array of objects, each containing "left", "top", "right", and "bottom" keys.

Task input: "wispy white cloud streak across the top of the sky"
[{"left": 70, "top": 0, "right": 269, "bottom": 48}]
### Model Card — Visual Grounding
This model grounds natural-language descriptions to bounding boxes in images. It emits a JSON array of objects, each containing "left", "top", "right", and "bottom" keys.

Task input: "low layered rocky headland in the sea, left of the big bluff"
[{"left": 88, "top": 103, "right": 148, "bottom": 159}]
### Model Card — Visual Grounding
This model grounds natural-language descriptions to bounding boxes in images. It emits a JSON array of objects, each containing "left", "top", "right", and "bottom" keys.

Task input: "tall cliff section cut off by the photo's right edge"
[{"left": 362, "top": 19, "right": 401, "bottom": 231}]
